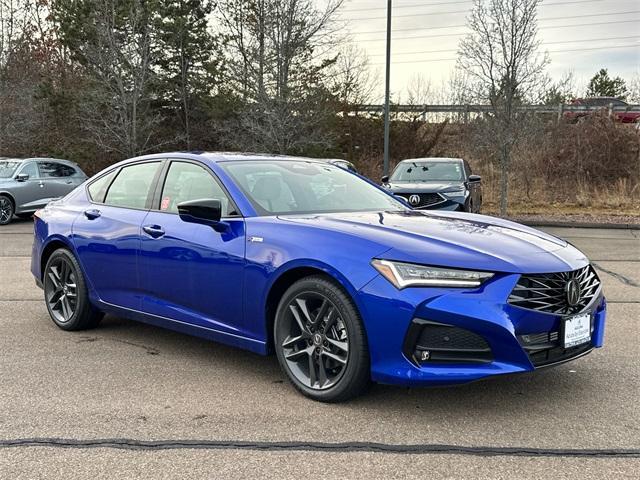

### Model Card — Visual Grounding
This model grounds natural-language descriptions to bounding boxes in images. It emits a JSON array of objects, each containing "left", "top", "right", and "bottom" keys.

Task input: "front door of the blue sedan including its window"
[{"left": 140, "top": 161, "right": 246, "bottom": 336}]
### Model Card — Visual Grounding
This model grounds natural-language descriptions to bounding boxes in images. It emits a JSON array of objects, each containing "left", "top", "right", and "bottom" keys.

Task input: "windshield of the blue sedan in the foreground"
[{"left": 221, "top": 160, "right": 407, "bottom": 215}]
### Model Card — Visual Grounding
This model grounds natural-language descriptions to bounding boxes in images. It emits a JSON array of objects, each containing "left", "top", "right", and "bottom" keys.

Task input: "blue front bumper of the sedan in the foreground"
[{"left": 359, "top": 274, "right": 606, "bottom": 386}]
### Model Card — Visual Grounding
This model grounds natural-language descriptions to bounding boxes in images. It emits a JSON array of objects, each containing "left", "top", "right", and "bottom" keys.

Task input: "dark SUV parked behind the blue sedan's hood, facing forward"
[{"left": 382, "top": 158, "right": 482, "bottom": 213}]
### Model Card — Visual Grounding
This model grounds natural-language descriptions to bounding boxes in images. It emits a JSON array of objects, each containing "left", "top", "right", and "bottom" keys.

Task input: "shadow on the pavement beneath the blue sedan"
[{"left": 92, "top": 316, "right": 604, "bottom": 418}]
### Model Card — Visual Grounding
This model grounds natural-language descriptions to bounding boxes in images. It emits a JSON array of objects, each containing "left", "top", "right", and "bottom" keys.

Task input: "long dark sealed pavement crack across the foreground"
[{"left": 0, "top": 438, "right": 640, "bottom": 458}]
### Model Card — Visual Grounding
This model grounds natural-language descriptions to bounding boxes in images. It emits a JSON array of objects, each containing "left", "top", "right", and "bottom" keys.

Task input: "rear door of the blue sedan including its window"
[{"left": 73, "top": 160, "right": 162, "bottom": 310}]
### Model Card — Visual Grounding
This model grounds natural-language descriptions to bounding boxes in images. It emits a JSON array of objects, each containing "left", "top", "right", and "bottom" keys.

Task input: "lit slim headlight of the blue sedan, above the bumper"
[{"left": 371, "top": 259, "right": 493, "bottom": 289}]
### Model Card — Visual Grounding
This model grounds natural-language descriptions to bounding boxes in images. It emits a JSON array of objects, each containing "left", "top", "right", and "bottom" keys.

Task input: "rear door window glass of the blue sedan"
[{"left": 104, "top": 162, "right": 160, "bottom": 208}]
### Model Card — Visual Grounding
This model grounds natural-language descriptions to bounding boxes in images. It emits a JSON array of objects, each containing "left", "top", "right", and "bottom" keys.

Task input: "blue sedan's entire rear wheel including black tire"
[{"left": 42, "top": 248, "right": 103, "bottom": 331}]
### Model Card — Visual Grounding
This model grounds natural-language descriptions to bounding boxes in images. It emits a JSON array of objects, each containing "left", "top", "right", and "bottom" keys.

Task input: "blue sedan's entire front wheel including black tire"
[{"left": 273, "top": 275, "right": 370, "bottom": 402}]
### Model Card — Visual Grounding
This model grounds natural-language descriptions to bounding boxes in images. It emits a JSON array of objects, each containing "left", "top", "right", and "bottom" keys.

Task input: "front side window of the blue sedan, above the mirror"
[{"left": 160, "top": 162, "right": 236, "bottom": 217}]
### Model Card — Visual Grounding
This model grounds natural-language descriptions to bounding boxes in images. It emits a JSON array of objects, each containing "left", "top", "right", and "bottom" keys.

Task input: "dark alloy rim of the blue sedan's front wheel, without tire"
[{"left": 278, "top": 292, "right": 349, "bottom": 390}]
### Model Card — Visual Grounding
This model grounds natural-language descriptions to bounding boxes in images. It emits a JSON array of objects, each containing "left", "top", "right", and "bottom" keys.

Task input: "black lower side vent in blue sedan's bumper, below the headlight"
[{"left": 404, "top": 319, "right": 493, "bottom": 364}]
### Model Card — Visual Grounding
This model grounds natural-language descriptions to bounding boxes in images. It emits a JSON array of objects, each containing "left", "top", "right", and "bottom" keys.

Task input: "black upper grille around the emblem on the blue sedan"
[{"left": 508, "top": 265, "right": 600, "bottom": 314}]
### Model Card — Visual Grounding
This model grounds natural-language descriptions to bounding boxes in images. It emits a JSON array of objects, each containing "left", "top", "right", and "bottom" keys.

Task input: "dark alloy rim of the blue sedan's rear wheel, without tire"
[{"left": 45, "top": 257, "right": 78, "bottom": 323}]
